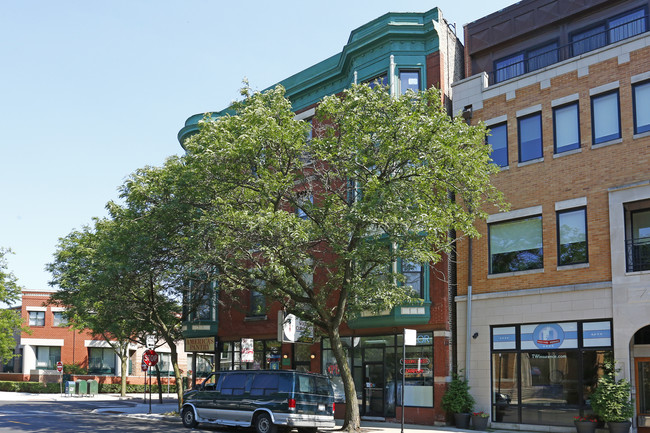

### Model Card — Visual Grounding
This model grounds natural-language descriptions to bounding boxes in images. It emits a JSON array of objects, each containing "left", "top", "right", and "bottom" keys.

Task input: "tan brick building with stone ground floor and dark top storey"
[{"left": 453, "top": 0, "right": 650, "bottom": 431}]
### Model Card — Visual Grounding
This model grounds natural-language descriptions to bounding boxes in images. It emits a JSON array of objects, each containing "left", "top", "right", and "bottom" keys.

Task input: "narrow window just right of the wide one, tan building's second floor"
[{"left": 558, "top": 209, "right": 588, "bottom": 265}]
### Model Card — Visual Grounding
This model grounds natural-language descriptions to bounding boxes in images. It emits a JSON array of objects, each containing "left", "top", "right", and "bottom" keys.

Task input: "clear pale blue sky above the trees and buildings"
[{"left": 0, "top": 0, "right": 514, "bottom": 296}]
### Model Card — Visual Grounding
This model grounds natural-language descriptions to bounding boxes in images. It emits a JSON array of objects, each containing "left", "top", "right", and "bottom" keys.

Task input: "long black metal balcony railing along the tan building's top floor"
[{"left": 489, "top": 15, "right": 648, "bottom": 84}]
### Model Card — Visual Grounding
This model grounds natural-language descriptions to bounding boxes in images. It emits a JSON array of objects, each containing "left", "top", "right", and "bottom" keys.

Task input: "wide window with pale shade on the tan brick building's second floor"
[{"left": 490, "top": 216, "right": 544, "bottom": 274}]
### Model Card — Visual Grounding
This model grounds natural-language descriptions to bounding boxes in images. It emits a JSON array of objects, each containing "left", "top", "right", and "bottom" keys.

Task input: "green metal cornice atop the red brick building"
[{"left": 178, "top": 8, "right": 441, "bottom": 145}]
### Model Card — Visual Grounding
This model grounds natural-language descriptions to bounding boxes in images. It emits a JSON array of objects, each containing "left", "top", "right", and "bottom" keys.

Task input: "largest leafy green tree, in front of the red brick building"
[{"left": 168, "top": 85, "right": 500, "bottom": 431}]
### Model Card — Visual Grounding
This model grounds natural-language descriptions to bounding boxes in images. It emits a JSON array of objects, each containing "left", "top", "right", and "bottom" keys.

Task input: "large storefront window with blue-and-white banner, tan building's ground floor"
[{"left": 492, "top": 320, "right": 612, "bottom": 426}]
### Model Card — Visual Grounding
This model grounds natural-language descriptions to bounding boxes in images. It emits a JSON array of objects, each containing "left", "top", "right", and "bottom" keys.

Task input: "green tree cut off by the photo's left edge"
[{"left": 0, "top": 248, "right": 23, "bottom": 362}]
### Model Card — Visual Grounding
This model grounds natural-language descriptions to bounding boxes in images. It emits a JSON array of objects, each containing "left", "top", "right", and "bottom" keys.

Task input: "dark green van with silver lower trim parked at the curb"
[{"left": 181, "top": 370, "right": 335, "bottom": 433}]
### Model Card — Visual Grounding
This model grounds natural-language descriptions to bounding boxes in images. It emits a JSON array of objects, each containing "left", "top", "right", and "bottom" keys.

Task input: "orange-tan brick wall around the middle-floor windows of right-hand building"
[{"left": 458, "top": 43, "right": 650, "bottom": 295}]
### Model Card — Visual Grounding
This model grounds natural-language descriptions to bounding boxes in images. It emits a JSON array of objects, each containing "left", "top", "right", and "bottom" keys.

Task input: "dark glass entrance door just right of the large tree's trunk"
[{"left": 361, "top": 347, "right": 386, "bottom": 417}]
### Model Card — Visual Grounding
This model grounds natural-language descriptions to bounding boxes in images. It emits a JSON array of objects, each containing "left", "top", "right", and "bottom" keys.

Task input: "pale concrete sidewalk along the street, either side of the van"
[{"left": 0, "top": 391, "right": 554, "bottom": 433}]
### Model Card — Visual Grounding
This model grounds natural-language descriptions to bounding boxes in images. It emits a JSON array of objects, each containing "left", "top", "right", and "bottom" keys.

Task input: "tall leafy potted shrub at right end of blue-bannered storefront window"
[{"left": 591, "top": 361, "right": 634, "bottom": 433}]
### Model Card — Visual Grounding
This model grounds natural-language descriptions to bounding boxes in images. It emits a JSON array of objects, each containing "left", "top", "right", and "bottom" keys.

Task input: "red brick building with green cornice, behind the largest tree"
[{"left": 178, "top": 8, "right": 463, "bottom": 424}]
